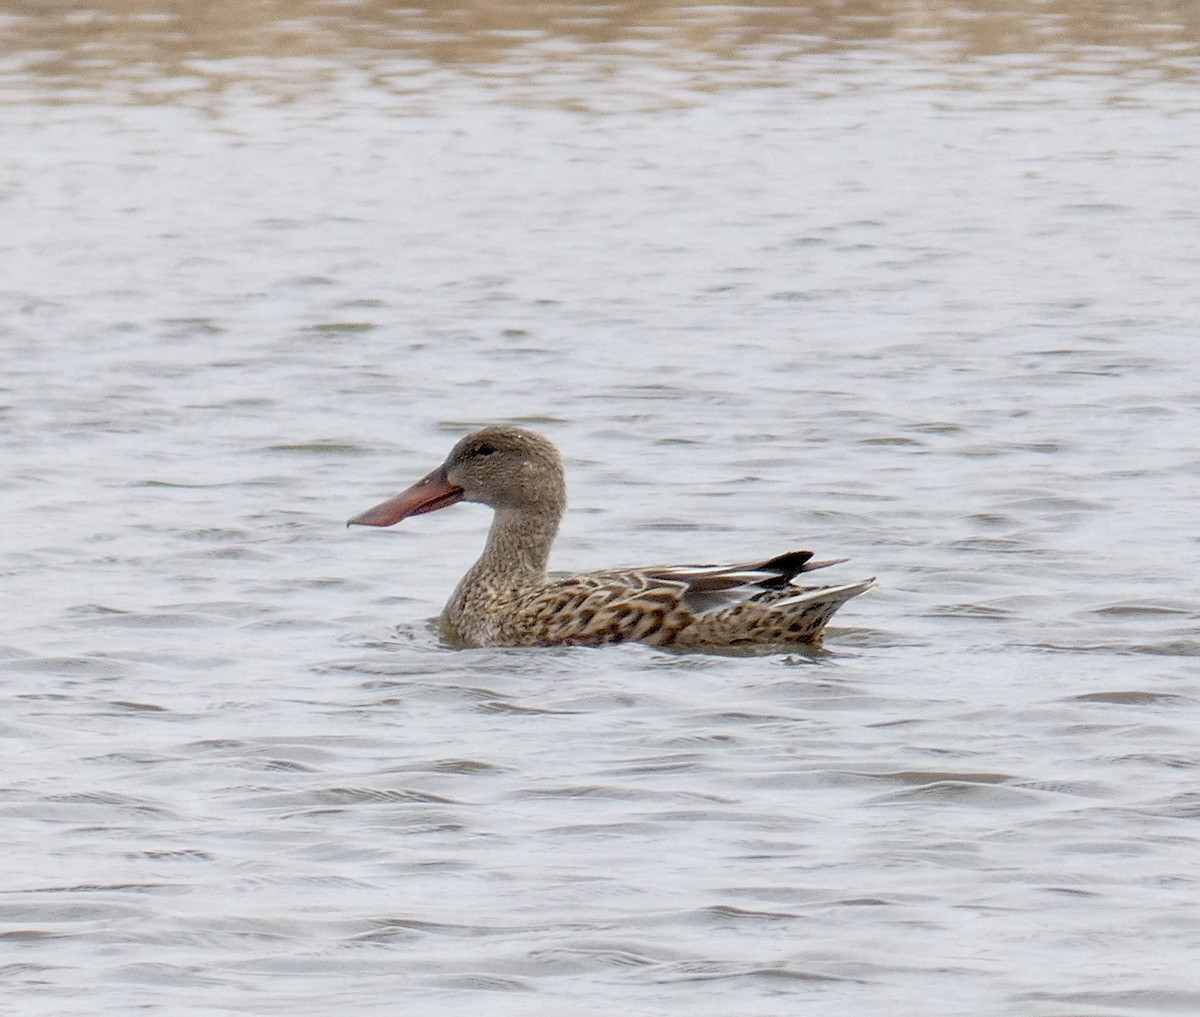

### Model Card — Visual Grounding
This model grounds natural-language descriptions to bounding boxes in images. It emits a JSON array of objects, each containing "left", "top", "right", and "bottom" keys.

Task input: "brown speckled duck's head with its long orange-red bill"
[{"left": 347, "top": 425, "right": 566, "bottom": 526}]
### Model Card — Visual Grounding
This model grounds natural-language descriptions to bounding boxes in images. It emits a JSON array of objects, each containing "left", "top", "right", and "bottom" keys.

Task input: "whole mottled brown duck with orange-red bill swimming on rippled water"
[{"left": 347, "top": 425, "right": 875, "bottom": 651}]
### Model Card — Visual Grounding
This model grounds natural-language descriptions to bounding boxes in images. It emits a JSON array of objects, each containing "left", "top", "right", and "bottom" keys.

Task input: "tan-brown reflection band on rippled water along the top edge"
[{"left": 7, "top": 0, "right": 1200, "bottom": 101}]
